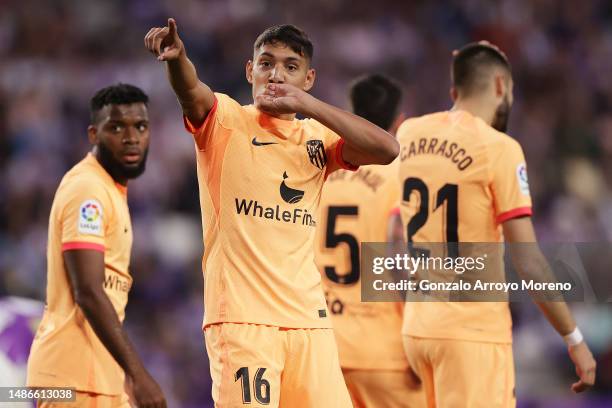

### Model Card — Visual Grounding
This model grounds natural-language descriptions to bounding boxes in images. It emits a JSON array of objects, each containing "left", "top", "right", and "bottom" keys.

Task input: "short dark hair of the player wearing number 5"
[{"left": 350, "top": 74, "right": 402, "bottom": 130}]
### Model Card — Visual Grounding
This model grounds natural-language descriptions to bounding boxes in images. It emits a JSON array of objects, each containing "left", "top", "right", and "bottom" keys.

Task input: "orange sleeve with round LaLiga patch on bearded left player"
[{"left": 59, "top": 179, "right": 113, "bottom": 252}]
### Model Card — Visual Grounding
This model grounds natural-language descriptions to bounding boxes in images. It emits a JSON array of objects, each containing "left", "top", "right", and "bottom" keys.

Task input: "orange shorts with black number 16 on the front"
[{"left": 204, "top": 323, "right": 352, "bottom": 408}]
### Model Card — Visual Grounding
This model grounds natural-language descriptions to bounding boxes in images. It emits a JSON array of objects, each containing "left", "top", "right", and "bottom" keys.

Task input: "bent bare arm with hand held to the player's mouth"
[{"left": 255, "top": 84, "right": 399, "bottom": 166}]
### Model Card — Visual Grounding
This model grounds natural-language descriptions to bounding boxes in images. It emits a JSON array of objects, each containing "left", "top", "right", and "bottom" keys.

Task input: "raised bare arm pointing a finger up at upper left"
[{"left": 144, "top": 18, "right": 215, "bottom": 127}]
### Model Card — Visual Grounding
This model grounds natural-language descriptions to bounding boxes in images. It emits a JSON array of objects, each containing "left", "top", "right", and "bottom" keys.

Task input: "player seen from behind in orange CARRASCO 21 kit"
[{"left": 398, "top": 42, "right": 595, "bottom": 408}]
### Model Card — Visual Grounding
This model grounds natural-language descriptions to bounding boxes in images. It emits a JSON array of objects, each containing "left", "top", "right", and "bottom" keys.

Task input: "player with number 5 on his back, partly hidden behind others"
[{"left": 315, "top": 75, "right": 423, "bottom": 408}]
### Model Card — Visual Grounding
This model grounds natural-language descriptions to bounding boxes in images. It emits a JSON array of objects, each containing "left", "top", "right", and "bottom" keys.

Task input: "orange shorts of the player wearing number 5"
[{"left": 342, "top": 369, "right": 426, "bottom": 408}]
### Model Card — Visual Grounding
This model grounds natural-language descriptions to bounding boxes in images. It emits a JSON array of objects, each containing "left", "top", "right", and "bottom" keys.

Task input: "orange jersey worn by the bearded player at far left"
[{"left": 28, "top": 154, "right": 132, "bottom": 395}]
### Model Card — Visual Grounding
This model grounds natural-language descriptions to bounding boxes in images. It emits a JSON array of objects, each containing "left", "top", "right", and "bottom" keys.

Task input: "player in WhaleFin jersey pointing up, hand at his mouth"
[{"left": 145, "top": 19, "right": 399, "bottom": 407}]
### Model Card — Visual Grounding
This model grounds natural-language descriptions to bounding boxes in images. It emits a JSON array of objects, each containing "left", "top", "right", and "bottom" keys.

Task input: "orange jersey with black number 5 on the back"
[{"left": 315, "top": 161, "right": 408, "bottom": 370}]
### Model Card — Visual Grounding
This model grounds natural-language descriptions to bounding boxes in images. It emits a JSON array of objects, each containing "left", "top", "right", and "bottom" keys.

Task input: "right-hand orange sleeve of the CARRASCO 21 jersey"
[{"left": 490, "top": 140, "right": 532, "bottom": 224}]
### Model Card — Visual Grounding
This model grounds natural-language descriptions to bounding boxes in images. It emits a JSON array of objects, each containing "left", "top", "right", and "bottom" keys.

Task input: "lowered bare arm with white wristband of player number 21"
[{"left": 503, "top": 217, "right": 596, "bottom": 393}]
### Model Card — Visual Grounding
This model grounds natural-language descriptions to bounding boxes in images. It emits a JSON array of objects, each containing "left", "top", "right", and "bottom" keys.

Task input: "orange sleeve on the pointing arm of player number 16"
[{"left": 183, "top": 92, "right": 244, "bottom": 150}]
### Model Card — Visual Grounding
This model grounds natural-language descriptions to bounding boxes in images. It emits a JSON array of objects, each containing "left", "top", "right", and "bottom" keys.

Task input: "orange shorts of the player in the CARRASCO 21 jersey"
[{"left": 404, "top": 336, "right": 516, "bottom": 408}]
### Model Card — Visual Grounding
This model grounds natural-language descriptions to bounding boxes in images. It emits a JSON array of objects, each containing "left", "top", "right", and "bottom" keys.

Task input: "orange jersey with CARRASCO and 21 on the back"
[{"left": 398, "top": 111, "right": 531, "bottom": 343}]
